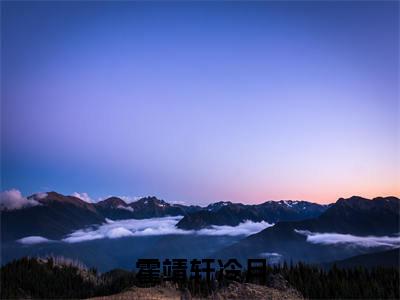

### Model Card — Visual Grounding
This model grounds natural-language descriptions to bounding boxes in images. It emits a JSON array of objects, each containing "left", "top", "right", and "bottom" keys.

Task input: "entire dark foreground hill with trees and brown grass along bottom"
[{"left": 0, "top": 258, "right": 400, "bottom": 299}]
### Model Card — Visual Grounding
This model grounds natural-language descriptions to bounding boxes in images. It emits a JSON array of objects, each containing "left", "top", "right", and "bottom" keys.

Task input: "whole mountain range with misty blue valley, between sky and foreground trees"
[{"left": 1, "top": 192, "right": 400, "bottom": 270}]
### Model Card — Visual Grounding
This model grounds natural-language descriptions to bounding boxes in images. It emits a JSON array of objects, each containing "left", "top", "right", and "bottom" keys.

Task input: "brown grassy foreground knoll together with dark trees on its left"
[{"left": 0, "top": 257, "right": 303, "bottom": 299}]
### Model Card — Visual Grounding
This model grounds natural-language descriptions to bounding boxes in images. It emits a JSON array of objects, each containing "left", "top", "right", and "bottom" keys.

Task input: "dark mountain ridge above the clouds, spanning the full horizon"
[{"left": 1, "top": 192, "right": 399, "bottom": 252}]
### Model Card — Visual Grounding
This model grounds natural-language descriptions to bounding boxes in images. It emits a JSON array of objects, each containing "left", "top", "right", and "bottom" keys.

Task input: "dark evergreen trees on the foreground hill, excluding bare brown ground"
[{"left": 1, "top": 258, "right": 400, "bottom": 299}]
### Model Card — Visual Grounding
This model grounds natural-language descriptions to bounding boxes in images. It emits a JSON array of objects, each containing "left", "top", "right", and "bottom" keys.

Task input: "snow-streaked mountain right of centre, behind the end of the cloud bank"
[{"left": 177, "top": 200, "right": 328, "bottom": 230}]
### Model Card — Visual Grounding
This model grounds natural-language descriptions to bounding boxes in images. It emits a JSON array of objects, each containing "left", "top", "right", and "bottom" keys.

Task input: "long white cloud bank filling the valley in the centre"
[{"left": 63, "top": 216, "right": 272, "bottom": 243}]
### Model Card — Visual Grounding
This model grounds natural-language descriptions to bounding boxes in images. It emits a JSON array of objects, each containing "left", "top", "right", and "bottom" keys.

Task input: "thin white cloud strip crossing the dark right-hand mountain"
[{"left": 295, "top": 229, "right": 400, "bottom": 248}]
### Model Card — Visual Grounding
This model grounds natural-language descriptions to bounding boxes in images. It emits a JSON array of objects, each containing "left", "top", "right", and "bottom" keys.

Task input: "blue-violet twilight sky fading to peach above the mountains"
[{"left": 1, "top": 1, "right": 400, "bottom": 204}]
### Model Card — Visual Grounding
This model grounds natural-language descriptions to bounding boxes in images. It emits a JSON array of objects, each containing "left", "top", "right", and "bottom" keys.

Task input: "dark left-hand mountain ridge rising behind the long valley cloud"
[{"left": 1, "top": 192, "right": 194, "bottom": 241}]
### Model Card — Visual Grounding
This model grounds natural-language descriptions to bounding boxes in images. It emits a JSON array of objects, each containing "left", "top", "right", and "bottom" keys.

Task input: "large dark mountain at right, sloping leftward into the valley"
[{"left": 216, "top": 197, "right": 400, "bottom": 262}]
